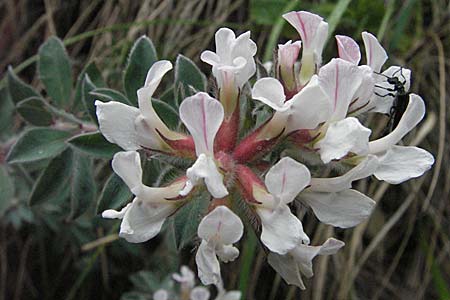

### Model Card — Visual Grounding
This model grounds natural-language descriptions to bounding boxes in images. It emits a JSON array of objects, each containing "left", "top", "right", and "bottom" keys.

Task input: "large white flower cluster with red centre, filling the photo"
[{"left": 96, "top": 11, "right": 434, "bottom": 290}]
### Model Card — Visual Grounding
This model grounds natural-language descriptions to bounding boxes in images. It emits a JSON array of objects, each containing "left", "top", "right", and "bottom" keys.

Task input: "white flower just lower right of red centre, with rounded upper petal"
[{"left": 253, "top": 157, "right": 311, "bottom": 254}]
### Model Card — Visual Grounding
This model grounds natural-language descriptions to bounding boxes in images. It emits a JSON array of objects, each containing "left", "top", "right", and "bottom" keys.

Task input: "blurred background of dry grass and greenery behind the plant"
[{"left": 0, "top": 0, "right": 450, "bottom": 300}]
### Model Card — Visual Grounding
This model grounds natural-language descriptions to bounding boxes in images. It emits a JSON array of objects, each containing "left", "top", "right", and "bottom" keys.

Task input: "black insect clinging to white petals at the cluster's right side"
[{"left": 375, "top": 67, "right": 410, "bottom": 132}]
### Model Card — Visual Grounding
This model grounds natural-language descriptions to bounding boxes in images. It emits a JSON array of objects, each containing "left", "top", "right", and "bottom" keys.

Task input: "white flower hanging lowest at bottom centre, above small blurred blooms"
[{"left": 195, "top": 206, "right": 244, "bottom": 285}]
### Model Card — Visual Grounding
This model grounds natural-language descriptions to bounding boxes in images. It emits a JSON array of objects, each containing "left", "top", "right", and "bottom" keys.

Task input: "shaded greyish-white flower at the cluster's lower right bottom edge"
[{"left": 267, "top": 238, "right": 345, "bottom": 290}]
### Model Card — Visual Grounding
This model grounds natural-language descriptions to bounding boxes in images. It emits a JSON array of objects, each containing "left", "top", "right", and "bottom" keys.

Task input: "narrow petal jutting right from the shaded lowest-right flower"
[{"left": 290, "top": 238, "right": 345, "bottom": 278}]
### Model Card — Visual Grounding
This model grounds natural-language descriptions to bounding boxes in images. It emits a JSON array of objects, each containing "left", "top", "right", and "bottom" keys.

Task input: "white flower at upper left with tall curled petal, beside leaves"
[{"left": 95, "top": 60, "right": 184, "bottom": 150}]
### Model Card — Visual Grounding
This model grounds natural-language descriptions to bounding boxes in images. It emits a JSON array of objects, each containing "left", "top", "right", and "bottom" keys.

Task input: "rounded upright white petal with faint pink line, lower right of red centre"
[{"left": 265, "top": 157, "right": 311, "bottom": 204}]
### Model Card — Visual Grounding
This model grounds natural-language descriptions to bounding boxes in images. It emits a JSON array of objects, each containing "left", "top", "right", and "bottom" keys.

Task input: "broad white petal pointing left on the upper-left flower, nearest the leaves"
[{"left": 95, "top": 100, "right": 141, "bottom": 150}]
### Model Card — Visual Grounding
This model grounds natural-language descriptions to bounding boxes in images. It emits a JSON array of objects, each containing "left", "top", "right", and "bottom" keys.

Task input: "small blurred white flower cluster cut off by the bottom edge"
[{"left": 153, "top": 266, "right": 241, "bottom": 300}]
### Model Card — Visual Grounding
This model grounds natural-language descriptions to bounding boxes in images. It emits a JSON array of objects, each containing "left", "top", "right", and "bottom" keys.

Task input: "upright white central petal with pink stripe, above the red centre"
[{"left": 180, "top": 92, "right": 224, "bottom": 156}]
